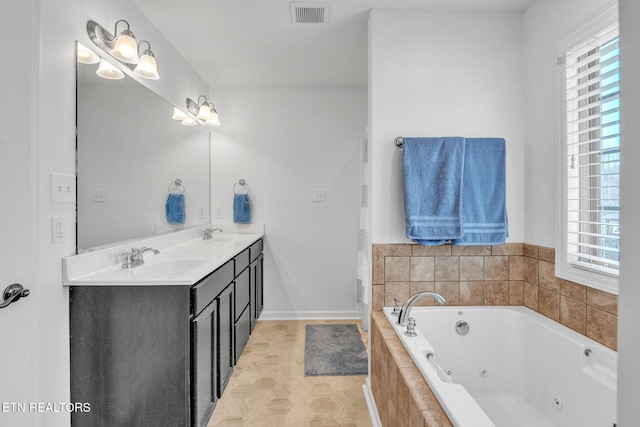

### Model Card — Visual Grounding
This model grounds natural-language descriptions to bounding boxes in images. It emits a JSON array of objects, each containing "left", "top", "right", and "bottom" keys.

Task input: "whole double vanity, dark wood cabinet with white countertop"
[{"left": 63, "top": 226, "right": 263, "bottom": 427}]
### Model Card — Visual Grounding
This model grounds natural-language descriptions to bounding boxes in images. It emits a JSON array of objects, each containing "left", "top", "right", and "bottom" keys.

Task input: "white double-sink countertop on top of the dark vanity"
[{"left": 63, "top": 224, "right": 264, "bottom": 286}]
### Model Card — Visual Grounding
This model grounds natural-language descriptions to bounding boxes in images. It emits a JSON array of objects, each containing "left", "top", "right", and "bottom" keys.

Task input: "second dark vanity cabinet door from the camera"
[{"left": 217, "top": 283, "right": 235, "bottom": 397}]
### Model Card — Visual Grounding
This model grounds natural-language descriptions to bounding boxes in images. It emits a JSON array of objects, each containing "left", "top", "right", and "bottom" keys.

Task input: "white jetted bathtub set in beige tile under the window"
[{"left": 384, "top": 306, "right": 617, "bottom": 427}]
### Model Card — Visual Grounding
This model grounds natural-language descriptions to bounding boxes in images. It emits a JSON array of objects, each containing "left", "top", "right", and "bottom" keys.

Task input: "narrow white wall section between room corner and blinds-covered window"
[{"left": 524, "top": 0, "right": 610, "bottom": 247}]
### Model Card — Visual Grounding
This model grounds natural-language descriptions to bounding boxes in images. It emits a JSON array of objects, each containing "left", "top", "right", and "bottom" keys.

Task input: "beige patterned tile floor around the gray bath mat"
[{"left": 208, "top": 320, "right": 371, "bottom": 427}]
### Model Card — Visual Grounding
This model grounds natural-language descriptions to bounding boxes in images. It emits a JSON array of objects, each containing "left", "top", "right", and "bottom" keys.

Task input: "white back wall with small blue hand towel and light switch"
[{"left": 211, "top": 87, "right": 367, "bottom": 319}]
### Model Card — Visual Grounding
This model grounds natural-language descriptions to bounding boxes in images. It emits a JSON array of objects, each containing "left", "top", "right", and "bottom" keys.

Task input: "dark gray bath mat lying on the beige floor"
[{"left": 304, "top": 324, "right": 368, "bottom": 377}]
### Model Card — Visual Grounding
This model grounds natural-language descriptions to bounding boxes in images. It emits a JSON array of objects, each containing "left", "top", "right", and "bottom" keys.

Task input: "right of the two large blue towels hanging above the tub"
[{"left": 451, "top": 138, "right": 509, "bottom": 245}]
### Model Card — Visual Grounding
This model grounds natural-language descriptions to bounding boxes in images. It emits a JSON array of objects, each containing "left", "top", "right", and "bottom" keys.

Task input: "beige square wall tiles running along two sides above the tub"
[{"left": 372, "top": 243, "right": 618, "bottom": 350}]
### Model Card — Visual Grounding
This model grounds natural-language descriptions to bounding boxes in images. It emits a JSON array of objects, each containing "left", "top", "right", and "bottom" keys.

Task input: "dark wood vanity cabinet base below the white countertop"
[{"left": 69, "top": 239, "right": 262, "bottom": 427}]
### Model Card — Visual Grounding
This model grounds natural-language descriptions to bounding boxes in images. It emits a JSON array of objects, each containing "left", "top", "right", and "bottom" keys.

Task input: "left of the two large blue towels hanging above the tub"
[{"left": 403, "top": 137, "right": 465, "bottom": 246}]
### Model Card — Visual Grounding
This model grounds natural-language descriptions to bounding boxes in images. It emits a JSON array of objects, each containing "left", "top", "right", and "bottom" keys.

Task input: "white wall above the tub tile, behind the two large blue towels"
[{"left": 369, "top": 10, "right": 524, "bottom": 243}]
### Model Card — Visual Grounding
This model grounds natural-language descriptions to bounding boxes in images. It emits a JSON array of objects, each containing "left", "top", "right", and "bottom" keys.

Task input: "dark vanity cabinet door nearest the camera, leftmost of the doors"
[{"left": 191, "top": 300, "right": 218, "bottom": 427}]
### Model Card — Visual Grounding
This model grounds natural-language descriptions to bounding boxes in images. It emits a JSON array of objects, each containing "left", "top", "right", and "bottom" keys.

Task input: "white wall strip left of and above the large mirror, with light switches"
[{"left": 25, "top": 0, "right": 208, "bottom": 427}]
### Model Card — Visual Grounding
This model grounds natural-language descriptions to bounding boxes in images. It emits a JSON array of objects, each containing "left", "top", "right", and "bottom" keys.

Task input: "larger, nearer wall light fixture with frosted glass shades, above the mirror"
[{"left": 87, "top": 19, "right": 160, "bottom": 80}]
